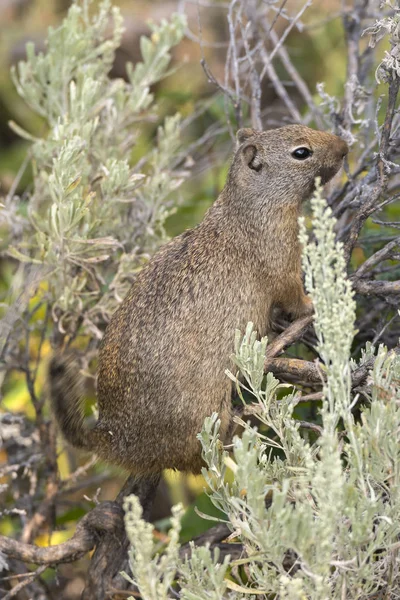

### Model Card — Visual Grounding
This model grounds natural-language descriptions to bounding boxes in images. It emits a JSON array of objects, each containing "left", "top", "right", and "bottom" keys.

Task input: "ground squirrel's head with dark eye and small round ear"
[{"left": 229, "top": 125, "right": 349, "bottom": 204}]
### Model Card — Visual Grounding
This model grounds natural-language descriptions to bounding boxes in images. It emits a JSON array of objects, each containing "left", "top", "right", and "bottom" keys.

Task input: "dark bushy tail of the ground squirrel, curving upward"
[{"left": 48, "top": 353, "right": 109, "bottom": 452}]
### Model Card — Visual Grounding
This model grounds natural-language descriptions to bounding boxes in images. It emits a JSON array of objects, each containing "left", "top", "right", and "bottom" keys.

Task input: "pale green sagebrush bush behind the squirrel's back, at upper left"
[{"left": 0, "top": 0, "right": 185, "bottom": 337}]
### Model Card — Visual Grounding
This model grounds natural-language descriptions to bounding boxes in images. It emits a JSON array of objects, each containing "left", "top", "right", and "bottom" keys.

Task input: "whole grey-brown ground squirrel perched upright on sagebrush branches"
[{"left": 50, "top": 125, "right": 348, "bottom": 502}]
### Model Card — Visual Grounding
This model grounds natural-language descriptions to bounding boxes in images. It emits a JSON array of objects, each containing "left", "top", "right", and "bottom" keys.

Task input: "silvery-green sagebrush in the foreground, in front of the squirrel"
[{"left": 123, "top": 185, "right": 400, "bottom": 600}]
